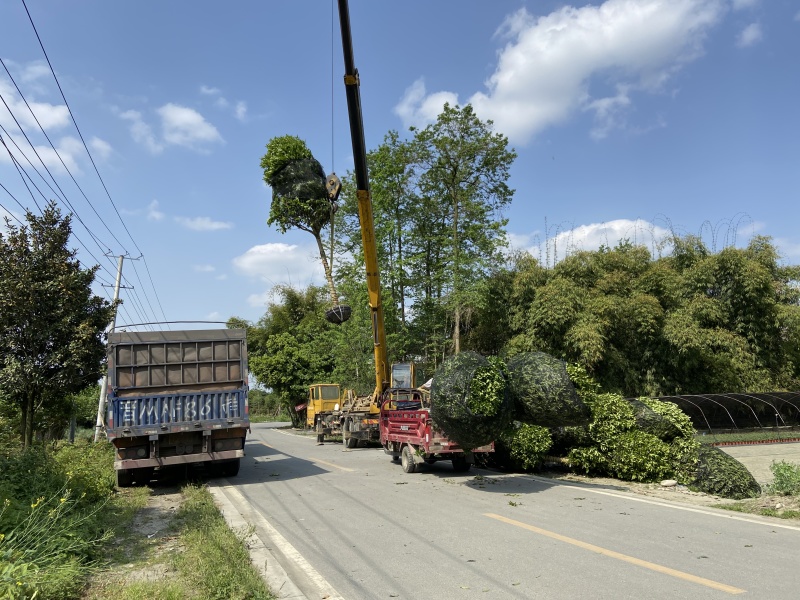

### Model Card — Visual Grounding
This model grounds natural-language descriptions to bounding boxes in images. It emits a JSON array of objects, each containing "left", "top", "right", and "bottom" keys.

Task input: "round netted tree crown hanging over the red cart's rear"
[{"left": 431, "top": 352, "right": 513, "bottom": 450}]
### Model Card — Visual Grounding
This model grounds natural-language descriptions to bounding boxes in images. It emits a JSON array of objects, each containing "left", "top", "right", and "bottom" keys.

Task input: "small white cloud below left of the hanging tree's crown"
[{"left": 233, "top": 242, "right": 324, "bottom": 288}]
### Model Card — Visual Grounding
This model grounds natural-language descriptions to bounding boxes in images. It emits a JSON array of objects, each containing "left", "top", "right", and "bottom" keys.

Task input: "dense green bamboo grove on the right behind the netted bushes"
[{"left": 508, "top": 236, "right": 800, "bottom": 396}]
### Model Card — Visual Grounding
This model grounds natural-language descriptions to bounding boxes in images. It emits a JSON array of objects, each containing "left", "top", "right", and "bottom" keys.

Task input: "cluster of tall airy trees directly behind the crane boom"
[{"left": 337, "top": 105, "right": 516, "bottom": 364}]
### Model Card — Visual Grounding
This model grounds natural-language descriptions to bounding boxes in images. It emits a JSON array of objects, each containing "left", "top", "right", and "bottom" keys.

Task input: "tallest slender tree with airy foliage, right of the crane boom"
[{"left": 411, "top": 104, "right": 516, "bottom": 353}]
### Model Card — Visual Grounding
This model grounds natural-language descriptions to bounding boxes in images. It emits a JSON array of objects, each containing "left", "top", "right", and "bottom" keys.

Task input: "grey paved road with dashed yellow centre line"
[{"left": 212, "top": 424, "right": 800, "bottom": 600}]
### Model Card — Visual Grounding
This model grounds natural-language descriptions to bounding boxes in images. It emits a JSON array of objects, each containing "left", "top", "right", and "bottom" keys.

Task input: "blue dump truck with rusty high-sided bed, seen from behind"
[{"left": 106, "top": 329, "right": 250, "bottom": 487}]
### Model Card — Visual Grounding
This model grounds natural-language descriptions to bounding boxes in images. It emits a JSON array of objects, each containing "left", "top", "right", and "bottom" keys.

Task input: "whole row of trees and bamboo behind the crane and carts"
[{"left": 241, "top": 106, "right": 800, "bottom": 418}]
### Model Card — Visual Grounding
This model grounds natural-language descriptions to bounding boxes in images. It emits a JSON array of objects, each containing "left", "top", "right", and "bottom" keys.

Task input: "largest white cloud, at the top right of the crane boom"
[{"left": 395, "top": 0, "right": 726, "bottom": 144}]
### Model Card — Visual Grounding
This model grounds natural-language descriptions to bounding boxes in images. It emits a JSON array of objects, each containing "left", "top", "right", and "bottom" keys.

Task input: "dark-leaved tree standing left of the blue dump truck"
[{"left": 0, "top": 203, "right": 114, "bottom": 447}]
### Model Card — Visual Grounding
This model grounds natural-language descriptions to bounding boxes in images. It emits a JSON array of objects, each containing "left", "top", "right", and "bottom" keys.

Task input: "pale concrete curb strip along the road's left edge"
[{"left": 208, "top": 479, "right": 344, "bottom": 600}]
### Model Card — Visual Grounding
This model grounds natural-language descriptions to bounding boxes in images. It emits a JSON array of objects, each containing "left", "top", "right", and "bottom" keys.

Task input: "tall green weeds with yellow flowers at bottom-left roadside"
[{"left": 0, "top": 442, "right": 144, "bottom": 600}]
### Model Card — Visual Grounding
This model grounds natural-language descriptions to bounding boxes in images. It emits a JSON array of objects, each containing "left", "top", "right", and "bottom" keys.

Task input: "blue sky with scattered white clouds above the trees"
[{"left": 0, "top": 0, "right": 800, "bottom": 327}]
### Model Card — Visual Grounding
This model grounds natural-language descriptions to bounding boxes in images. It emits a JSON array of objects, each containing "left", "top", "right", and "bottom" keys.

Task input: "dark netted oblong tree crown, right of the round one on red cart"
[{"left": 508, "top": 352, "right": 592, "bottom": 427}]
